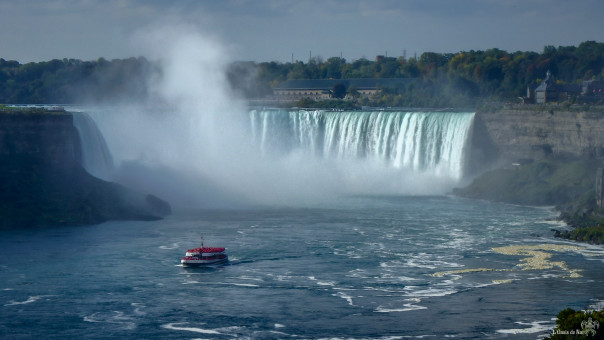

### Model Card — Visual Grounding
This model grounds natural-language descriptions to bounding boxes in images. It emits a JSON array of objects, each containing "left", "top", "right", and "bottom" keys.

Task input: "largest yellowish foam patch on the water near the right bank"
[{"left": 492, "top": 244, "right": 582, "bottom": 277}]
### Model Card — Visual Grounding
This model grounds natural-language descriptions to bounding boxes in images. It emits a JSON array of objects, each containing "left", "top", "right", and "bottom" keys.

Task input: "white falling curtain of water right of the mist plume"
[{"left": 250, "top": 110, "right": 474, "bottom": 180}]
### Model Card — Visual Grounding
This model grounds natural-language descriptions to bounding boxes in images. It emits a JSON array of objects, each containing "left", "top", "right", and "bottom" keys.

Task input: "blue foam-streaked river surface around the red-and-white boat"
[{"left": 0, "top": 196, "right": 604, "bottom": 339}]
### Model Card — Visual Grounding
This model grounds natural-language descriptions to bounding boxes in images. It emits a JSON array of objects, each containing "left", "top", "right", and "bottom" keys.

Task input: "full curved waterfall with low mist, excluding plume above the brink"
[{"left": 76, "top": 110, "right": 474, "bottom": 206}]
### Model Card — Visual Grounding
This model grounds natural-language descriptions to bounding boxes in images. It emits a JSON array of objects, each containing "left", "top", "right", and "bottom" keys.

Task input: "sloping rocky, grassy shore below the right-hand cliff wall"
[{"left": 453, "top": 158, "right": 604, "bottom": 244}]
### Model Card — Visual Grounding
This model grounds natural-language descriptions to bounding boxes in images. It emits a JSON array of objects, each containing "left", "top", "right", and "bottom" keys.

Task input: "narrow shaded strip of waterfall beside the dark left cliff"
[{"left": 73, "top": 112, "right": 114, "bottom": 180}]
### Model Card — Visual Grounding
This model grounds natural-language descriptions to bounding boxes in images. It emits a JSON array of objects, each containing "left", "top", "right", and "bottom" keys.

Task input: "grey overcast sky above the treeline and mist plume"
[{"left": 0, "top": 0, "right": 604, "bottom": 63}]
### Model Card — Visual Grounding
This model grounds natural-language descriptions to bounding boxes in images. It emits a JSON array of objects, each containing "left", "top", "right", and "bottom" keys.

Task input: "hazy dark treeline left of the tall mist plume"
[{"left": 0, "top": 58, "right": 157, "bottom": 104}]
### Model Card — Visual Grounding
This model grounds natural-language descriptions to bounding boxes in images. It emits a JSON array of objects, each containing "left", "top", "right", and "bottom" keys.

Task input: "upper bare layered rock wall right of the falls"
[{"left": 474, "top": 109, "right": 604, "bottom": 160}]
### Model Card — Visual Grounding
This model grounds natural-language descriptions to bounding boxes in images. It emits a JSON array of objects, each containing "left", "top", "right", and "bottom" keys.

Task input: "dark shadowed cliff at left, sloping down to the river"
[{"left": 0, "top": 110, "right": 170, "bottom": 228}]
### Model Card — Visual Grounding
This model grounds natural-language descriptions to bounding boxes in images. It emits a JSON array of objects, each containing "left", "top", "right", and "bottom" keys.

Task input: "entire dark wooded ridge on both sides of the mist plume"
[{"left": 0, "top": 41, "right": 604, "bottom": 106}]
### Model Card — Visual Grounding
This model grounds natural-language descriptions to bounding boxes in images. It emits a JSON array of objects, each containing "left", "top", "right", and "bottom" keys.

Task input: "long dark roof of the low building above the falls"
[{"left": 274, "top": 78, "right": 417, "bottom": 90}]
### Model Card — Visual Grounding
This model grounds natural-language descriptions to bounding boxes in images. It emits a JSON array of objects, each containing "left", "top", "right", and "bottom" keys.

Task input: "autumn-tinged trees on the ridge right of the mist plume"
[{"left": 250, "top": 41, "right": 604, "bottom": 106}]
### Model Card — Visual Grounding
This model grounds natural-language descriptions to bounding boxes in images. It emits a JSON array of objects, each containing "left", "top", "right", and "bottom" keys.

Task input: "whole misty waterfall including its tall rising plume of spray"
[{"left": 68, "top": 25, "right": 474, "bottom": 207}]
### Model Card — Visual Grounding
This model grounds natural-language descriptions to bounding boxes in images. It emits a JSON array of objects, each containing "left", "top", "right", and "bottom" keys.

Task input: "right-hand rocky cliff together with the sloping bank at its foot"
[{"left": 453, "top": 106, "right": 604, "bottom": 224}]
